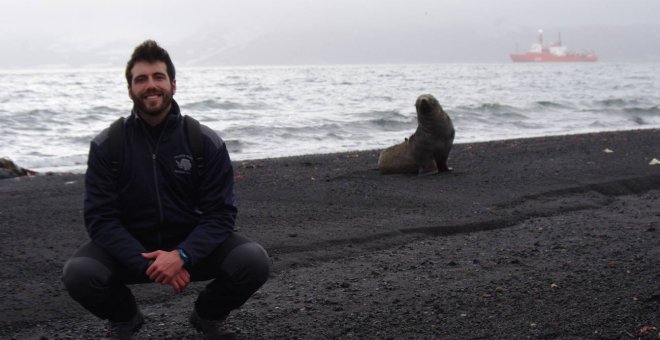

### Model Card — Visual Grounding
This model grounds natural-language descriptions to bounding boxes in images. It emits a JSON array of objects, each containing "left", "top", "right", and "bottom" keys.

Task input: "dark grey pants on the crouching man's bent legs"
[{"left": 62, "top": 233, "right": 270, "bottom": 321}]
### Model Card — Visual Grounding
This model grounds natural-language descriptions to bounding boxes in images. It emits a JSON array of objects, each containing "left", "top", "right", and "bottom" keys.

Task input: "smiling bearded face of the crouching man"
[{"left": 128, "top": 61, "right": 176, "bottom": 116}]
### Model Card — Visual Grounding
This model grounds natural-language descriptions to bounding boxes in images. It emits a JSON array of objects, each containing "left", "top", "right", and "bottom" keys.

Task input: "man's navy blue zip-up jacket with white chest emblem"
[{"left": 84, "top": 101, "right": 237, "bottom": 273}]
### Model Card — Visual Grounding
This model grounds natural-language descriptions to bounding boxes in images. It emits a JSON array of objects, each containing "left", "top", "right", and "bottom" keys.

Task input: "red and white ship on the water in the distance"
[{"left": 511, "top": 30, "right": 598, "bottom": 63}]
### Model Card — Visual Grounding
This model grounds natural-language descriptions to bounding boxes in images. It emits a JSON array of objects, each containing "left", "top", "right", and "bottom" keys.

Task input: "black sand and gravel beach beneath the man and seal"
[{"left": 0, "top": 129, "right": 660, "bottom": 339}]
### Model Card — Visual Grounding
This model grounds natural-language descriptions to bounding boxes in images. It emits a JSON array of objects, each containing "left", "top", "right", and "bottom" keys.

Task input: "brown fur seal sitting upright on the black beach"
[{"left": 378, "top": 94, "right": 455, "bottom": 176}]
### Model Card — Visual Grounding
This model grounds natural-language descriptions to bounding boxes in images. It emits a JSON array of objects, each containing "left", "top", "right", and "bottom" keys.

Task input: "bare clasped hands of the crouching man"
[{"left": 142, "top": 250, "right": 190, "bottom": 294}]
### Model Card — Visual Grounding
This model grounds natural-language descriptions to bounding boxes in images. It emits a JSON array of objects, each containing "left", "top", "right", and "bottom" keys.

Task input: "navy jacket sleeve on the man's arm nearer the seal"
[{"left": 179, "top": 126, "right": 237, "bottom": 264}]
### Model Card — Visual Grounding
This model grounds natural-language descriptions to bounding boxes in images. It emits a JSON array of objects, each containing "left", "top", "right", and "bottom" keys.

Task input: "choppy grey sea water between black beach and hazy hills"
[{"left": 0, "top": 62, "right": 660, "bottom": 172}]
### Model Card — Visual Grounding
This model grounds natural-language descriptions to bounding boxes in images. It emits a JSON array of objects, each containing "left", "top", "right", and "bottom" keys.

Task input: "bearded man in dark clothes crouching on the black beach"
[{"left": 62, "top": 40, "right": 270, "bottom": 339}]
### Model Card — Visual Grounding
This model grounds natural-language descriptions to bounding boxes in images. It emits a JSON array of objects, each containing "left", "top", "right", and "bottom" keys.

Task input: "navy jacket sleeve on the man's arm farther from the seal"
[{"left": 84, "top": 134, "right": 149, "bottom": 273}]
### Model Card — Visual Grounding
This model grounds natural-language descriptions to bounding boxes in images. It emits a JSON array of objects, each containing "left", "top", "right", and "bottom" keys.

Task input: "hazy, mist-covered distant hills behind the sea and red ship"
[{"left": 0, "top": 24, "right": 660, "bottom": 69}]
